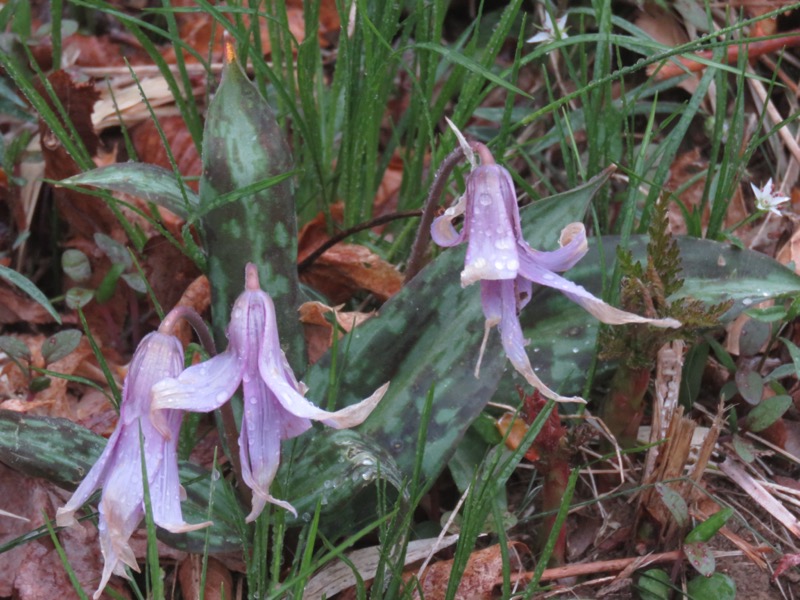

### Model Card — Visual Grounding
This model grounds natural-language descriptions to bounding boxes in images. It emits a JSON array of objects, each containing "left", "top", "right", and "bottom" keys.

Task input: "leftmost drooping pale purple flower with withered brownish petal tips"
[{"left": 56, "top": 332, "right": 211, "bottom": 599}]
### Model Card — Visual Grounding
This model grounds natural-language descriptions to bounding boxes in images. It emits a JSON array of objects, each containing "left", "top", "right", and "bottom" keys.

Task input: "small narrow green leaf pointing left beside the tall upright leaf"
[{"left": 61, "top": 163, "right": 200, "bottom": 219}]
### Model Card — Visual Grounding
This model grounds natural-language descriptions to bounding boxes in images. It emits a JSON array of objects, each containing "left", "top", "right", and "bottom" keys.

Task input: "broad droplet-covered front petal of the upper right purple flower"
[{"left": 461, "top": 165, "right": 520, "bottom": 286}]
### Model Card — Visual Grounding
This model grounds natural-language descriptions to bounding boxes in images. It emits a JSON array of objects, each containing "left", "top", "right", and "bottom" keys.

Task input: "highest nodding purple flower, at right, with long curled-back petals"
[{"left": 431, "top": 158, "right": 680, "bottom": 402}]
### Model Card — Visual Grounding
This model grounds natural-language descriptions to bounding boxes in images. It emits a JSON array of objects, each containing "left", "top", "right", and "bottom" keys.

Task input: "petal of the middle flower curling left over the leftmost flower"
[{"left": 151, "top": 351, "right": 243, "bottom": 418}]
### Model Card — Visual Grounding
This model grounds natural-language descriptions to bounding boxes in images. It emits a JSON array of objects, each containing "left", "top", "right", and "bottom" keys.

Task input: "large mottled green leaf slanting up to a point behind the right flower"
[{"left": 306, "top": 166, "right": 610, "bottom": 478}]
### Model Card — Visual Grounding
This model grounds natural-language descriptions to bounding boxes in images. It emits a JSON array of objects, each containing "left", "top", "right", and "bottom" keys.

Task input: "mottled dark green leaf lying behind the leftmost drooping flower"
[{"left": 0, "top": 410, "right": 241, "bottom": 552}]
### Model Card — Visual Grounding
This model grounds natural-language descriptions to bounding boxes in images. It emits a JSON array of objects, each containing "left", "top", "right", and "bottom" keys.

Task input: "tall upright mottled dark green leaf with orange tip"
[{"left": 199, "top": 50, "right": 305, "bottom": 371}]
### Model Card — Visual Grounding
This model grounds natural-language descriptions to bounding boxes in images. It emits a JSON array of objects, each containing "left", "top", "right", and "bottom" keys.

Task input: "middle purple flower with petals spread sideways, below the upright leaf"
[{"left": 152, "top": 264, "right": 389, "bottom": 522}]
